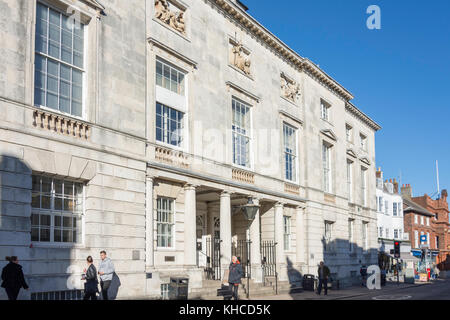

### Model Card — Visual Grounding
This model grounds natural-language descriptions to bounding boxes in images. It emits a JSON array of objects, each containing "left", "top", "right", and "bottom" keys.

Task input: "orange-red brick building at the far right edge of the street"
[{"left": 412, "top": 190, "right": 450, "bottom": 270}]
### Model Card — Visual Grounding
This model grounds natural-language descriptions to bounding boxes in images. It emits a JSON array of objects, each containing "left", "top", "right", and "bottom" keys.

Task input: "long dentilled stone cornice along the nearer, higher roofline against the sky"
[{"left": 207, "top": 0, "right": 353, "bottom": 101}]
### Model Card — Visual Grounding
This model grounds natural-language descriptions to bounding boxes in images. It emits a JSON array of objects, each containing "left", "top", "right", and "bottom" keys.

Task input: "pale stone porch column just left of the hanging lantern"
[{"left": 220, "top": 191, "right": 231, "bottom": 275}]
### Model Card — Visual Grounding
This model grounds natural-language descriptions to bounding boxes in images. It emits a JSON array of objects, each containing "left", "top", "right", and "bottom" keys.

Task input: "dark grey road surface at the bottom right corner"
[{"left": 338, "top": 279, "right": 450, "bottom": 300}]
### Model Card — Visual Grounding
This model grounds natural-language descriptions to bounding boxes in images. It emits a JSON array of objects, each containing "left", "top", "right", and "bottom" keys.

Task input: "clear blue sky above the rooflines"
[{"left": 242, "top": 0, "right": 450, "bottom": 196}]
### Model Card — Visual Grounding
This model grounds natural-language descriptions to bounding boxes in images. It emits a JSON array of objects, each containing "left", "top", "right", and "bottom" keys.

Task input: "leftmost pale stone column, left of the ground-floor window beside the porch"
[{"left": 145, "top": 176, "right": 154, "bottom": 268}]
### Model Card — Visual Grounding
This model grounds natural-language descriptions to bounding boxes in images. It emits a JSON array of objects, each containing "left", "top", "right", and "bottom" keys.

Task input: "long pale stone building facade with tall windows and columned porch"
[{"left": 0, "top": 0, "right": 380, "bottom": 298}]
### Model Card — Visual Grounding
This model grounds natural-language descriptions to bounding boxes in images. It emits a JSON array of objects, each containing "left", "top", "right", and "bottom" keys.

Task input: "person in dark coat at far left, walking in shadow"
[{"left": 2, "top": 256, "right": 28, "bottom": 300}]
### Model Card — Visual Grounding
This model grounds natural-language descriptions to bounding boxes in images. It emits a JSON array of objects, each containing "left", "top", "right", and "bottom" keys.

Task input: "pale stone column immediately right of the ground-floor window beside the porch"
[{"left": 184, "top": 184, "right": 197, "bottom": 266}]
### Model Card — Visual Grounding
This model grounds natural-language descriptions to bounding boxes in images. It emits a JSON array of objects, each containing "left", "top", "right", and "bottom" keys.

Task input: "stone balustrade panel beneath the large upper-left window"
[{"left": 33, "top": 110, "right": 91, "bottom": 140}]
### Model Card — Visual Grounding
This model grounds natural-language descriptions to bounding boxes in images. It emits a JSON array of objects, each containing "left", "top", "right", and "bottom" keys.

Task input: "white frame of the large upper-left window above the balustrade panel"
[{"left": 33, "top": 1, "right": 89, "bottom": 120}]
